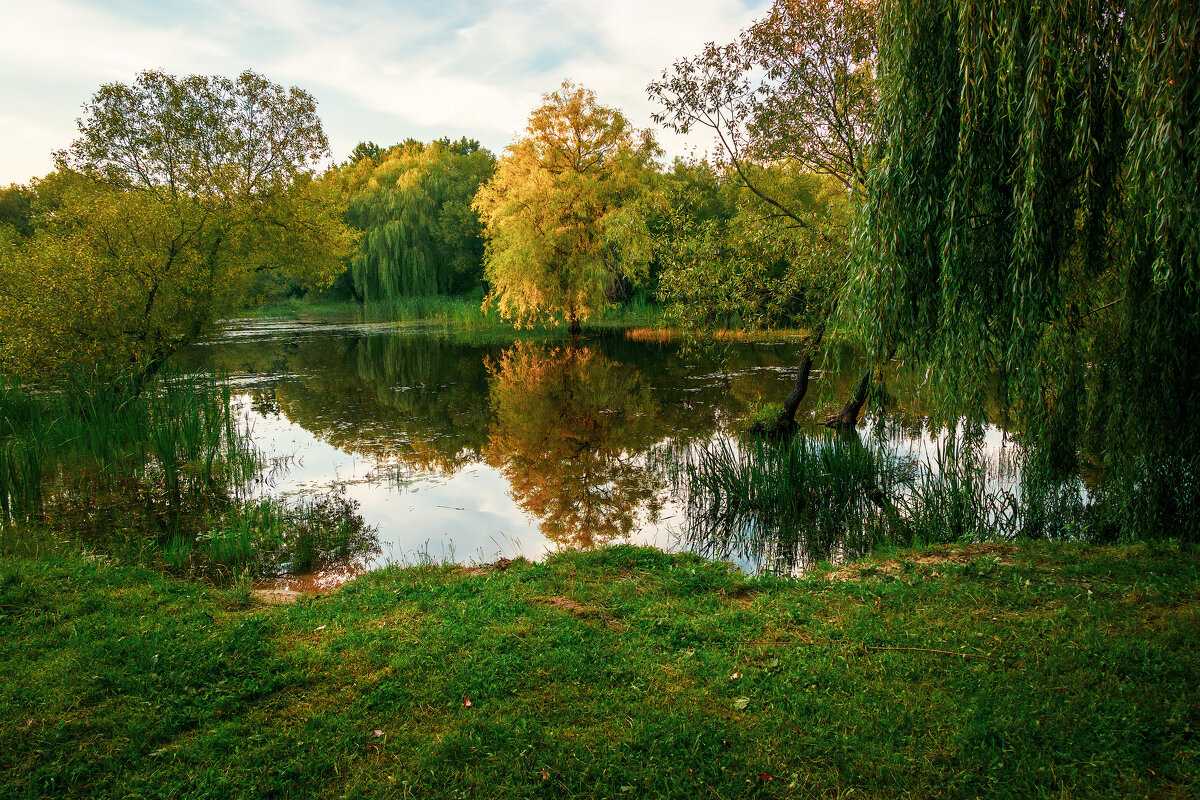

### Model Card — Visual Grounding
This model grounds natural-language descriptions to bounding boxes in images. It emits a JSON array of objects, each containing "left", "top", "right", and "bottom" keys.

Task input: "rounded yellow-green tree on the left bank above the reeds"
[{"left": 0, "top": 72, "right": 353, "bottom": 378}]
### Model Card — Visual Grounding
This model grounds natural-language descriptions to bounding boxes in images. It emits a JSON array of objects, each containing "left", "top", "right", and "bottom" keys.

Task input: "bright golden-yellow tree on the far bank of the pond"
[{"left": 475, "top": 82, "right": 659, "bottom": 333}]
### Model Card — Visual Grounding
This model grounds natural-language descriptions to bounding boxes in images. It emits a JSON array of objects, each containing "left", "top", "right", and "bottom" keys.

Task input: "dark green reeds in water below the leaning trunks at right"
[{"left": 665, "top": 432, "right": 1103, "bottom": 572}]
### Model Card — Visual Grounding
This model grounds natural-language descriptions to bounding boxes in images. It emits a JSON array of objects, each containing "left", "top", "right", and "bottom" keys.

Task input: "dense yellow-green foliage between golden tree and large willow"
[{"left": 629, "top": 161, "right": 847, "bottom": 329}]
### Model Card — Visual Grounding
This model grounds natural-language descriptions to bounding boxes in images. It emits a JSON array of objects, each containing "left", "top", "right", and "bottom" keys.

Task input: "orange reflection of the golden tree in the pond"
[{"left": 484, "top": 342, "right": 665, "bottom": 547}]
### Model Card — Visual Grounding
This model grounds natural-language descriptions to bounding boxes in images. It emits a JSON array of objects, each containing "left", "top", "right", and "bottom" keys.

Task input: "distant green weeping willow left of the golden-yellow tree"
[{"left": 337, "top": 139, "right": 496, "bottom": 302}]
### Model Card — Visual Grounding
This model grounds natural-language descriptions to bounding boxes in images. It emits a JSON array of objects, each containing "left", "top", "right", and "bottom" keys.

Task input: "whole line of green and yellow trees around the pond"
[{"left": 0, "top": 0, "right": 1200, "bottom": 537}]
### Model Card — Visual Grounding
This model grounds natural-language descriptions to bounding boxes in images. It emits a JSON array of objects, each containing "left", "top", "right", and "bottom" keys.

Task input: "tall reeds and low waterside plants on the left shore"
[{"left": 0, "top": 375, "right": 378, "bottom": 579}]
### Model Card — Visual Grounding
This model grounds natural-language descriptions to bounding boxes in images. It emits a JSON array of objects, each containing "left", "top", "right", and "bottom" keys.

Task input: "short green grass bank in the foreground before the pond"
[{"left": 0, "top": 545, "right": 1200, "bottom": 798}]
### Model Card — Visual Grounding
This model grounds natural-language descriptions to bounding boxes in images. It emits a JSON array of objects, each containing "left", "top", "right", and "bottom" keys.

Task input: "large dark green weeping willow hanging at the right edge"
[{"left": 852, "top": 0, "right": 1200, "bottom": 539}]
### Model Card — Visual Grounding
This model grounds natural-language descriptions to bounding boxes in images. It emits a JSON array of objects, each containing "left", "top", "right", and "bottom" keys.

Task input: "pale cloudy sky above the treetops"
[{"left": 0, "top": 0, "right": 770, "bottom": 185}]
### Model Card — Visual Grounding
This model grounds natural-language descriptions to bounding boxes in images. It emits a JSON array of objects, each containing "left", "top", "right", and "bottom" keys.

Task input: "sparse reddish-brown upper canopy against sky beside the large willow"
[{"left": 647, "top": 0, "right": 877, "bottom": 217}]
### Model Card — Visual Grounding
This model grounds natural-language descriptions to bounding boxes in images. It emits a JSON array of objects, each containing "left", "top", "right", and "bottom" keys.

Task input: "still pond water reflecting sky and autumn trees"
[{"left": 182, "top": 320, "right": 1022, "bottom": 588}]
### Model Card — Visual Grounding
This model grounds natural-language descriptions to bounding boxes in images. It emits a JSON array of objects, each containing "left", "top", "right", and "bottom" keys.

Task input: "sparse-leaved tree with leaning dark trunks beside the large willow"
[{"left": 648, "top": 0, "right": 877, "bottom": 427}]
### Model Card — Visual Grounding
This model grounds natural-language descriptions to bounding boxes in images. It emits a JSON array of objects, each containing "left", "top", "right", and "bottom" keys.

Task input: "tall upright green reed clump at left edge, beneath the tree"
[{"left": 0, "top": 374, "right": 260, "bottom": 533}]
